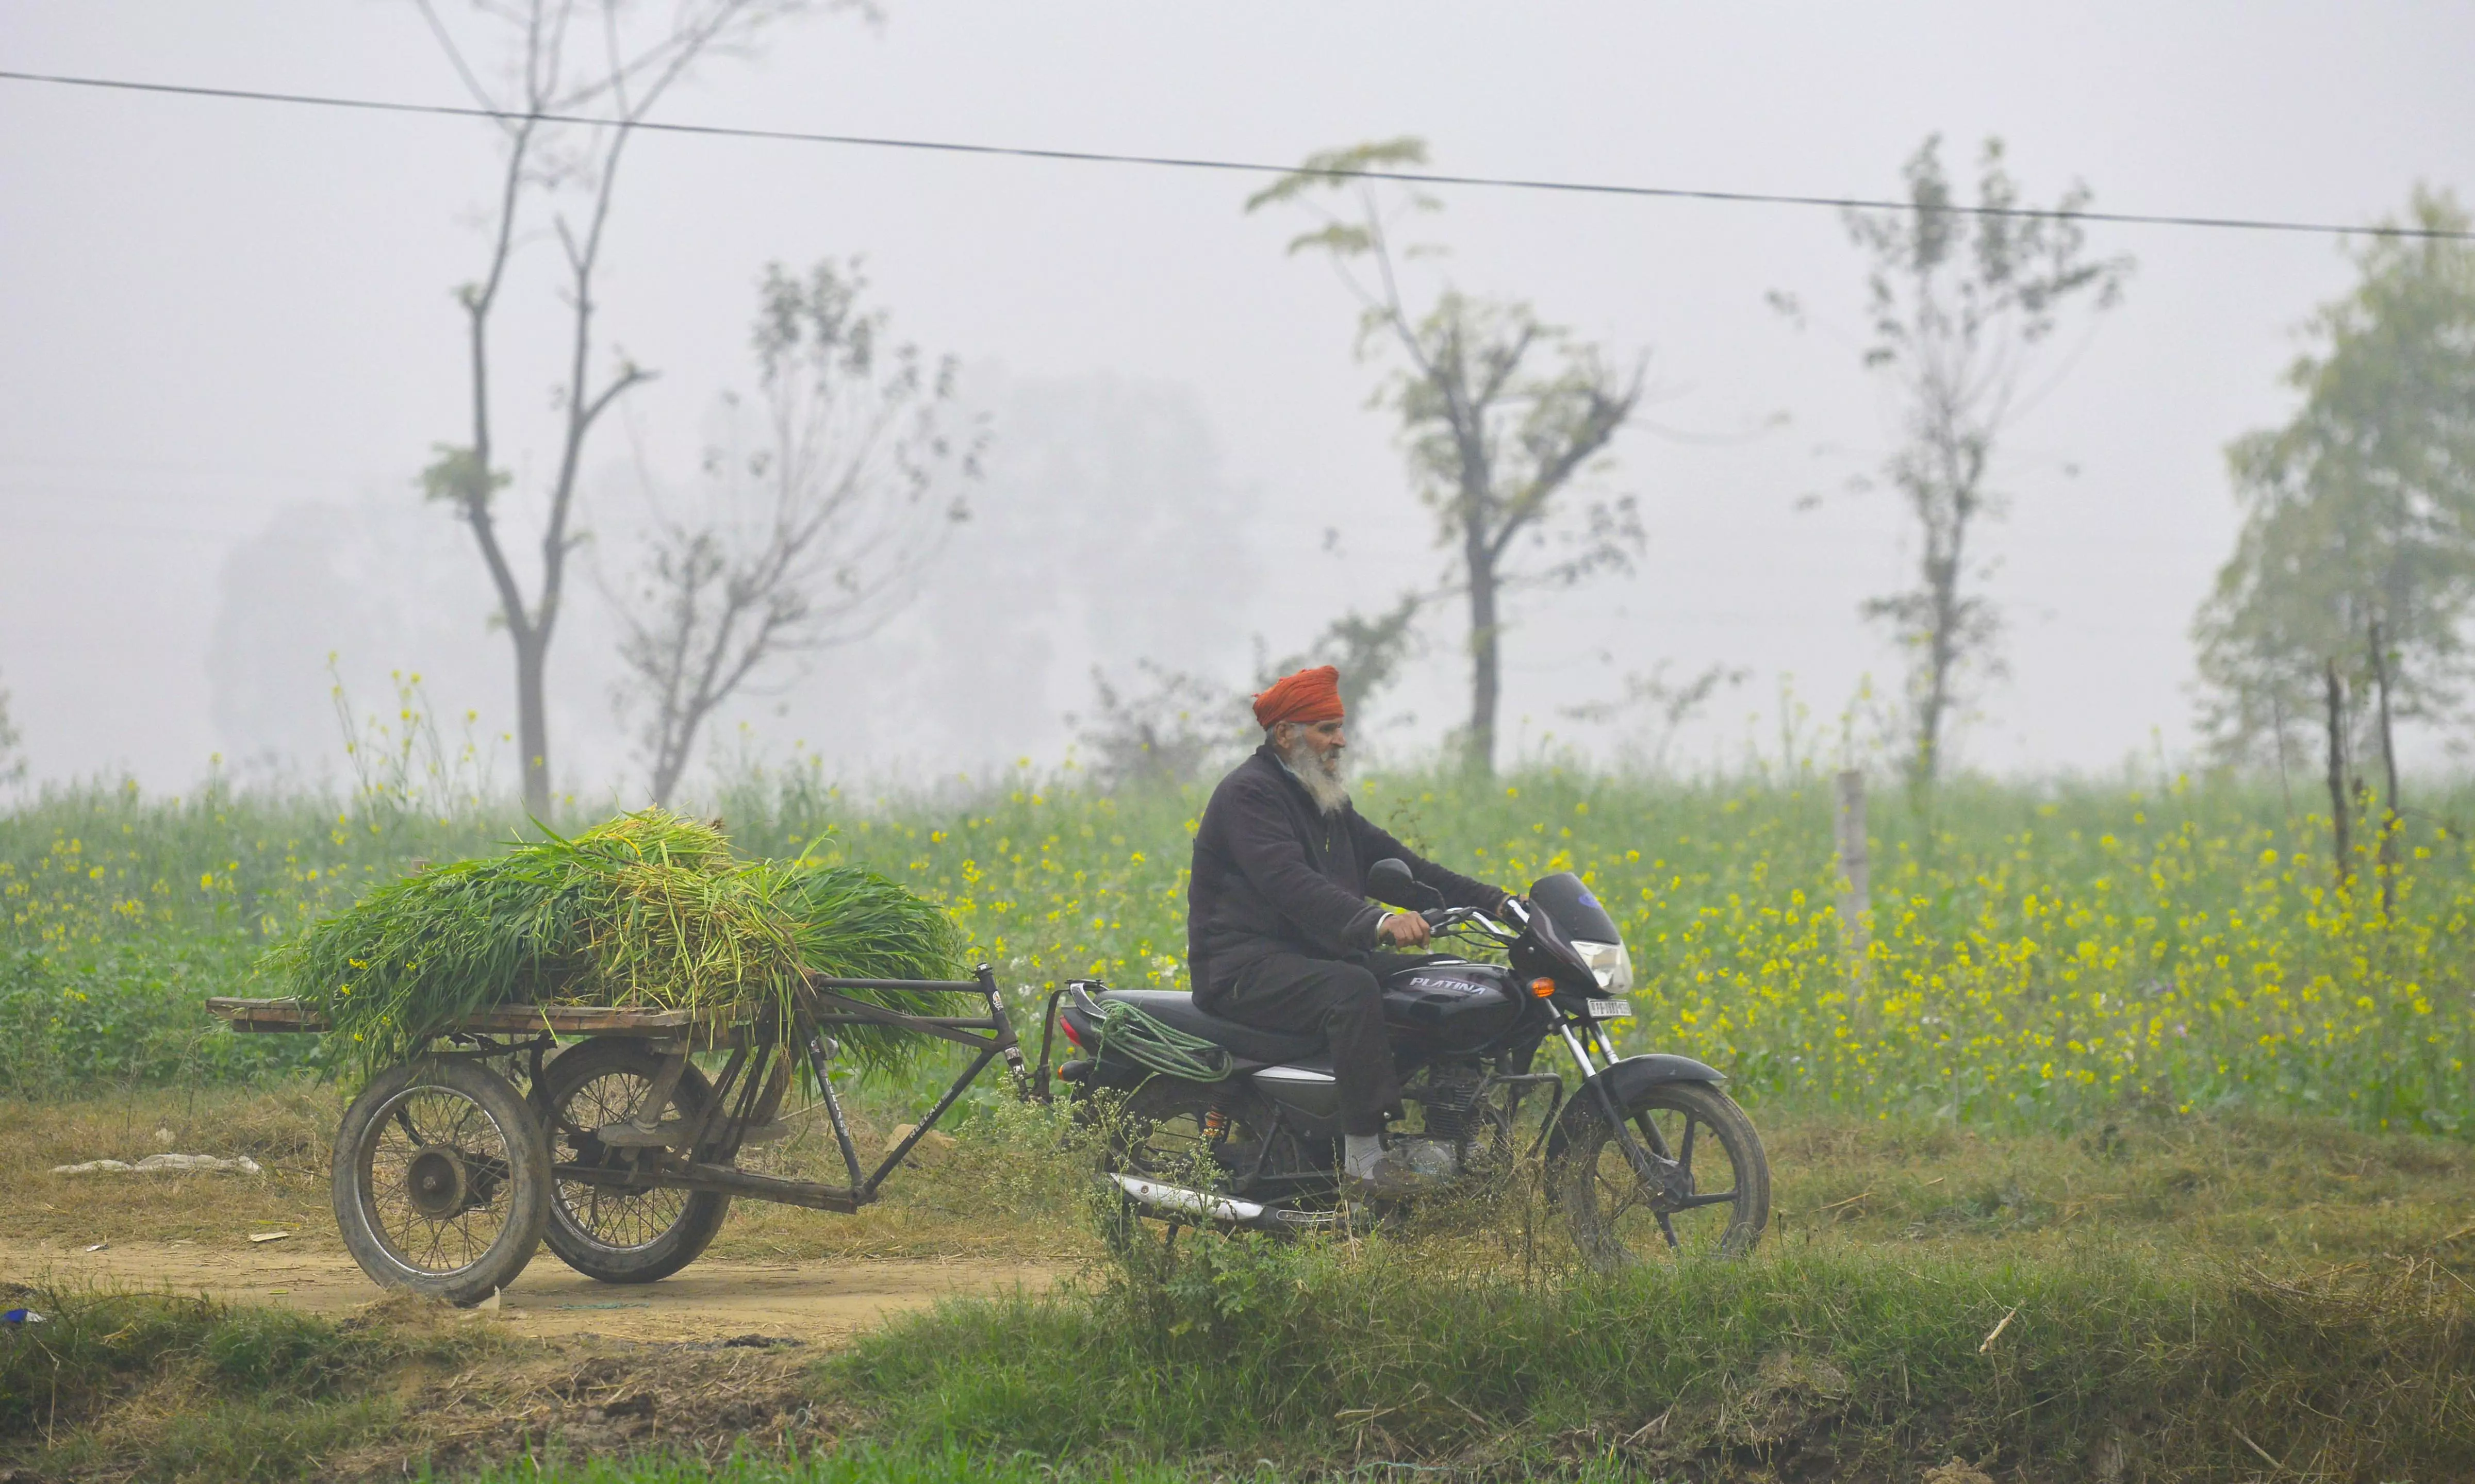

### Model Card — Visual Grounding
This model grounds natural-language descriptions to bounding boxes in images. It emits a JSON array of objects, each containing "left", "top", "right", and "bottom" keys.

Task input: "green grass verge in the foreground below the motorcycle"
[{"left": 824, "top": 1239, "right": 2475, "bottom": 1481}]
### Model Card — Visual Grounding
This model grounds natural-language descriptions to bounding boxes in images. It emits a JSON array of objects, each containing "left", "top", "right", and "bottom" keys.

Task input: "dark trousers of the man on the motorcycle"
[{"left": 1195, "top": 952, "right": 1438, "bottom": 1133}]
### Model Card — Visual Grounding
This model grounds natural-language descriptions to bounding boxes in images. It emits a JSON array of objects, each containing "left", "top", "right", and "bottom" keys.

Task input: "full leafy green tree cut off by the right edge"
[{"left": 2193, "top": 190, "right": 2475, "bottom": 786}]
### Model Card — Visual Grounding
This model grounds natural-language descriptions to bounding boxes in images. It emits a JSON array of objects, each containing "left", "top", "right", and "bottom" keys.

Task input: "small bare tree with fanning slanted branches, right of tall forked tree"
[{"left": 619, "top": 262, "right": 985, "bottom": 804}]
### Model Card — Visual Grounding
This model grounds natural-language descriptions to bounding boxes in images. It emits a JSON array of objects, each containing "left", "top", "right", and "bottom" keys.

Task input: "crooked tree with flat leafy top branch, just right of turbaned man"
[{"left": 1247, "top": 139, "right": 1643, "bottom": 774}]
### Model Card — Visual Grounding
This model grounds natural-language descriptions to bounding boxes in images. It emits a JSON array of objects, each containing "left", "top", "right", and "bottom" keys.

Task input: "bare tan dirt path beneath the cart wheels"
[{"left": 0, "top": 1237, "right": 1071, "bottom": 1343}]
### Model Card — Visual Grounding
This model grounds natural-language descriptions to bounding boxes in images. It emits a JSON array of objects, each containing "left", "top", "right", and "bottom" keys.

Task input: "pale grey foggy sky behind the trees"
[{"left": 0, "top": 0, "right": 2475, "bottom": 789}]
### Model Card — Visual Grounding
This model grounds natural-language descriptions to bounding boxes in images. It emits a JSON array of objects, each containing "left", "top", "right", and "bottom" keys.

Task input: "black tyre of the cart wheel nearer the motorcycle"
[{"left": 535, "top": 1037, "right": 730, "bottom": 1283}]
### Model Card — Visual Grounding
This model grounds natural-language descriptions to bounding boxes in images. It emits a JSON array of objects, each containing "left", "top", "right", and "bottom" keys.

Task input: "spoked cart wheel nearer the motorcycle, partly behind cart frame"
[{"left": 535, "top": 1037, "right": 730, "bottom": 1283}]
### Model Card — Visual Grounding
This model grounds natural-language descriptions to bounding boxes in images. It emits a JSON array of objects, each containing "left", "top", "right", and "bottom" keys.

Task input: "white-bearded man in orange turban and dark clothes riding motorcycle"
[{"left": 1185, "top": 665, "right": 1512, "bottom": 1195}]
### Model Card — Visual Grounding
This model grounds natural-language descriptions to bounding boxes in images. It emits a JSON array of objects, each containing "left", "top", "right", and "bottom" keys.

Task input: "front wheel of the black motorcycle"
[{"left": 1547, "top": 1083, "right": 1770, "bottom": 1269}]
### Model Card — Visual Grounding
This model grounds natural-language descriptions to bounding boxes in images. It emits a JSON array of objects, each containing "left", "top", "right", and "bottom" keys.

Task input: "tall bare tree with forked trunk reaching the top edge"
[{"left": 416, "top": 0, "right": 810, "bottom": 814}]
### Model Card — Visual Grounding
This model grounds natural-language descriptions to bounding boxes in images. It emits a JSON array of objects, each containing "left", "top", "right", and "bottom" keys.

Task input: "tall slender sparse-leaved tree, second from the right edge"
[{"left": 1772, "top": 134, "right": 2131, "bottom": 784}]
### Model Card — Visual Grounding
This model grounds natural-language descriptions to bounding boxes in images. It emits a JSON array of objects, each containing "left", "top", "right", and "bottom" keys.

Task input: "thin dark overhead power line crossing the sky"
[{"left": 0, "top": 69, "right": 2475, "bottom": 242}]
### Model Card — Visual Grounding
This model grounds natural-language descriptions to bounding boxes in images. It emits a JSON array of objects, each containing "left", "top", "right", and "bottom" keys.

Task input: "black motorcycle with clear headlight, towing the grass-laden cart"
[{"left": 1057, "top": 861, "right": 1770, "bottom": 1269}]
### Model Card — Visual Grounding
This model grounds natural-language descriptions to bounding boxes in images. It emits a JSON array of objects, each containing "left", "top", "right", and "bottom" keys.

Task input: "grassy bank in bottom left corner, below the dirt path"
[{"left": 0, "top": 1289, "right": 832, "bottom": 1484}]
